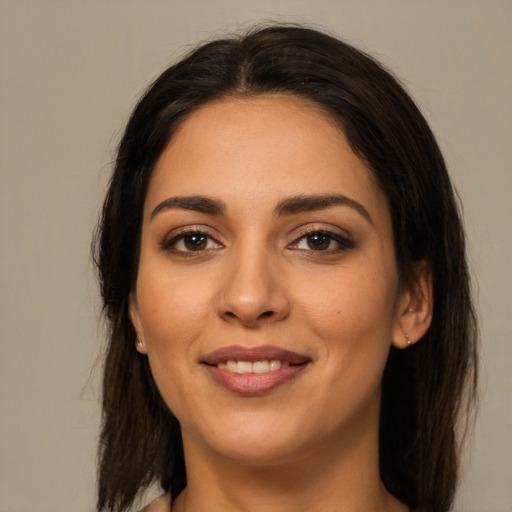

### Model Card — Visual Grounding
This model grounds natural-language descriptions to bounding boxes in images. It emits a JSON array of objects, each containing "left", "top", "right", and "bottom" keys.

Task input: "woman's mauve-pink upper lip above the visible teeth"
[{"left": 201, "top": 345, "right": 311, "bottom": 365}]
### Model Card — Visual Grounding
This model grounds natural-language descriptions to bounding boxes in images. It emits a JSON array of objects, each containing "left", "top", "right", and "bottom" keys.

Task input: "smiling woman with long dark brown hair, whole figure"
[{"left": 96, "top": 27, "right": 476, "bottom": 512}]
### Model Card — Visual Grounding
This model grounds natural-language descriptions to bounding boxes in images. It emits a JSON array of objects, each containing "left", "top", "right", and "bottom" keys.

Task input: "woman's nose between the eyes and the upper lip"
[{"left": 218, "top": 244, "right": 290, "bottom": 328}]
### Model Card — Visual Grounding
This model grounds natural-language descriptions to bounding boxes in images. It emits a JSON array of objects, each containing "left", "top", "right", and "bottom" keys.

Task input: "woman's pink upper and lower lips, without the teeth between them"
[{"left": 202, "top": 345, "right": 310, "bottom": 396}]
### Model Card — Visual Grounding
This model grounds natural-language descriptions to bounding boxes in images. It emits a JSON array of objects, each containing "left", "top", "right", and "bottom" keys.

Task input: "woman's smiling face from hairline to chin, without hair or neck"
[{"left": 130, "top": 95, "right": 403, "bottom": 464}]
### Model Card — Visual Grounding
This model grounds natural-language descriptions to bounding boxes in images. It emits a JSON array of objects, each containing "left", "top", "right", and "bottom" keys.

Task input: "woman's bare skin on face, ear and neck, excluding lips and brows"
[{"left": 130, "top": 95, "right": 432, "bottom": 512}]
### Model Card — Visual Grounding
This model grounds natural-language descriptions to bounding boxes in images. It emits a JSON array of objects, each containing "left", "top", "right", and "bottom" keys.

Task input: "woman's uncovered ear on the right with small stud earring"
[{"left": 392, "top": 261, "right": 434, "bottom": 348}]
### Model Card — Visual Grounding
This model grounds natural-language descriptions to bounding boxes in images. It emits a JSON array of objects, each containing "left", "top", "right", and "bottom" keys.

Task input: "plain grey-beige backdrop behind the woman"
[{"left": 0, "top": 0, "right": 512, "bottom": 512}]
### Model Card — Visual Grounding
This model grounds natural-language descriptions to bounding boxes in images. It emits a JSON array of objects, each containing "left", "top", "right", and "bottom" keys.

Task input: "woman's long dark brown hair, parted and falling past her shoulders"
[{"left": 95, "top": 26, "right": 477, "bottom": 512}]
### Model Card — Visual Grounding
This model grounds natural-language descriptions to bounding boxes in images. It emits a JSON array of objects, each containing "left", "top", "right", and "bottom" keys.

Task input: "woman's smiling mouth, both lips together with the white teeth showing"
[{"left": 201, "top": 345, "right": 311, "bottom": 396}]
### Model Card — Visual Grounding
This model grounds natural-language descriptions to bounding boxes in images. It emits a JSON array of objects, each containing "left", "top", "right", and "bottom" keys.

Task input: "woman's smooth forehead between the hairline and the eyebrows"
[{"left": 146, "top": 94, "right": 386, "bottom": 221}]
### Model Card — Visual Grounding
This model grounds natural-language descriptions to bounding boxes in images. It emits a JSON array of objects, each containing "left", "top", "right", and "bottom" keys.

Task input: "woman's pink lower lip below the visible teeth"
[{"left": 205, "top": 364, "right": 307, "bottom": 396}]
